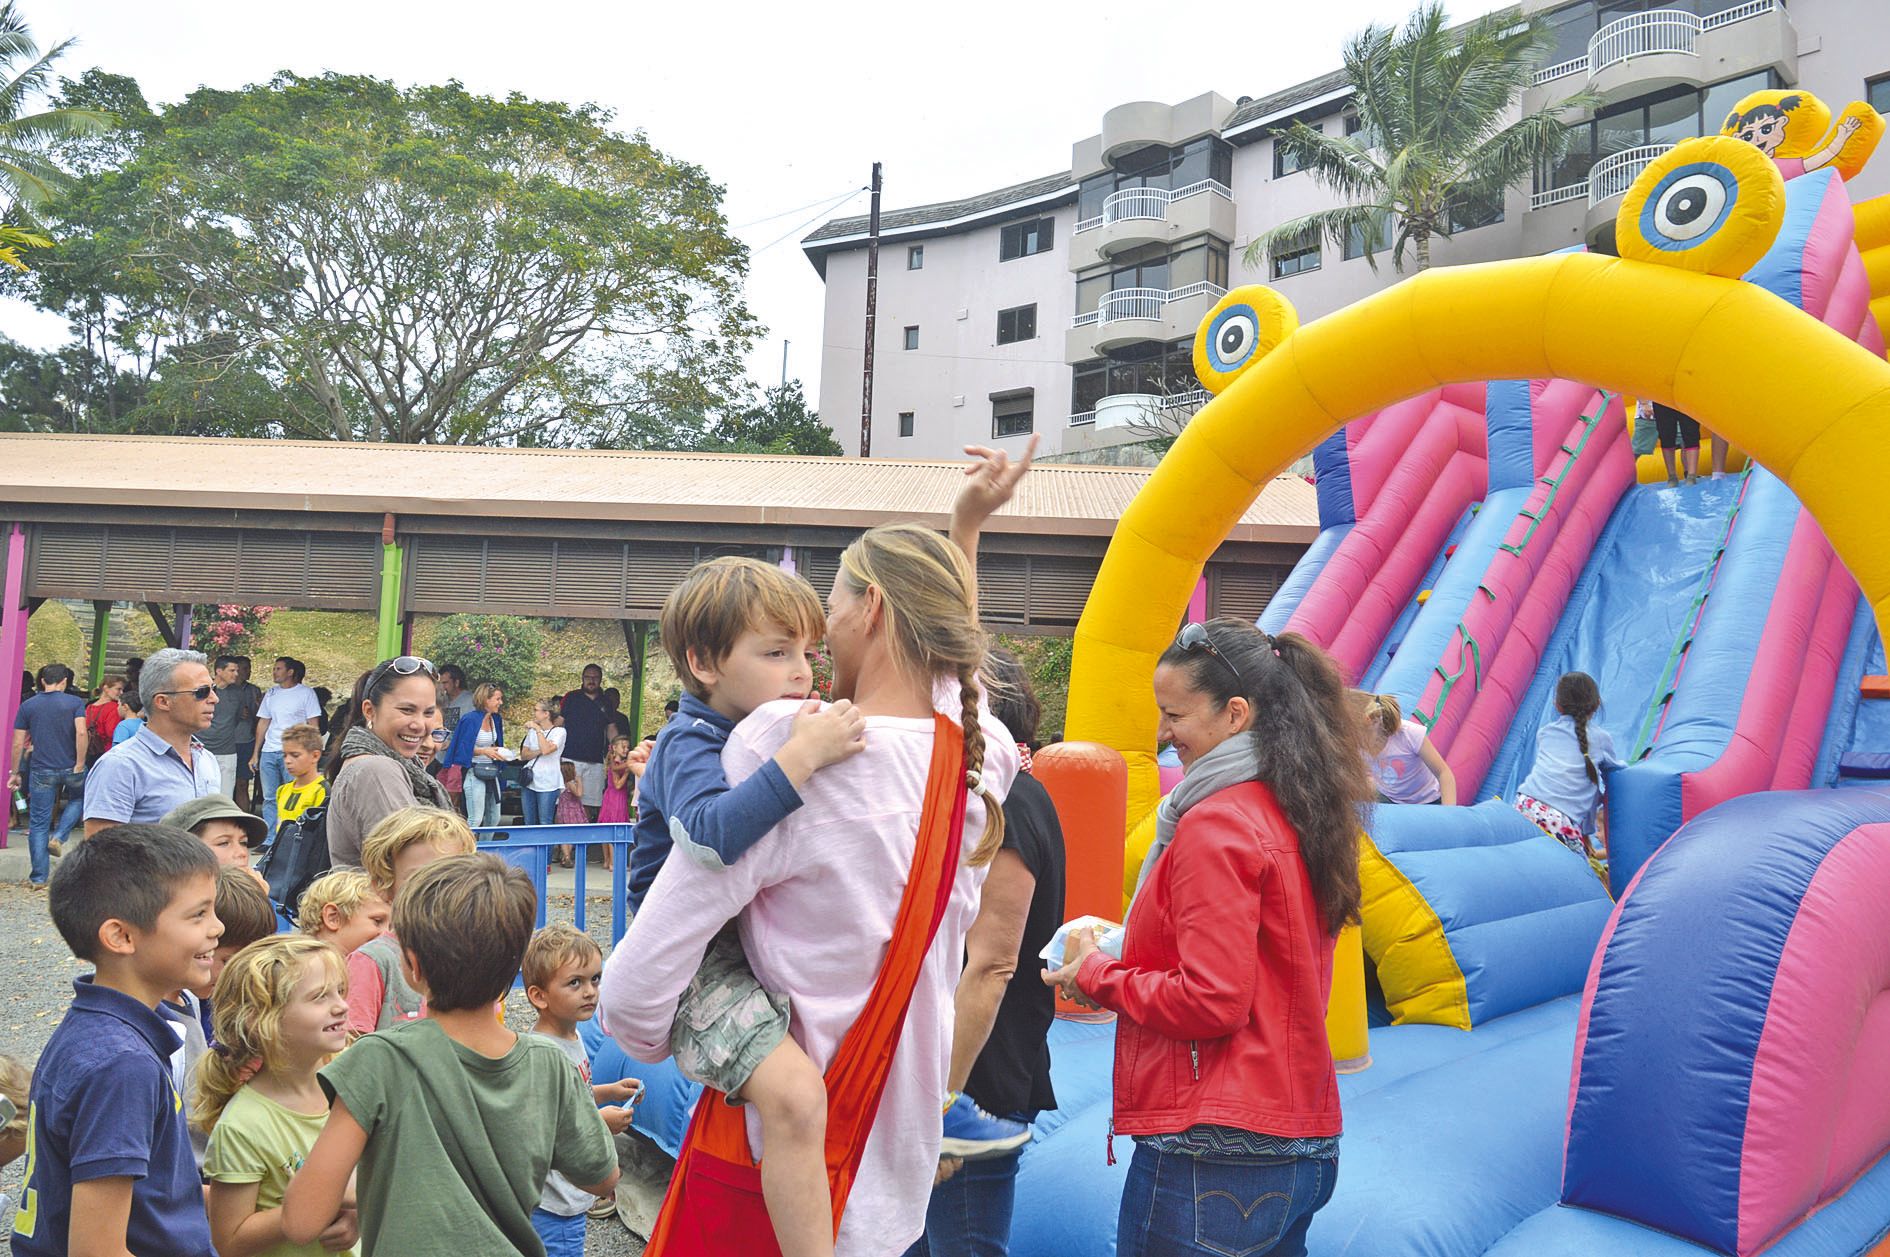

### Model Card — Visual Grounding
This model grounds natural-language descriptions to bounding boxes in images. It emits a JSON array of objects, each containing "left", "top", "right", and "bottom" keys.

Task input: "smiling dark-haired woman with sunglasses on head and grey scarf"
[{"left": 321, "top": 654, "right": 452, "bottom": 868}]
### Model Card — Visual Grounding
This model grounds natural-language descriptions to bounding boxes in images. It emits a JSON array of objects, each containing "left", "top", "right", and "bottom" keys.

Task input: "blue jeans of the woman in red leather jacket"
[{"left": 1115, "top": 1144, "right": 1338, "bottom": 1257}]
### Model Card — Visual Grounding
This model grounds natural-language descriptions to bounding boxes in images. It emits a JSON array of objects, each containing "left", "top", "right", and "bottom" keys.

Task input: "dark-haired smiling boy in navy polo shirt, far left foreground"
[{"left": 13, "top": 824, "right": 223, "bottom": 1257}]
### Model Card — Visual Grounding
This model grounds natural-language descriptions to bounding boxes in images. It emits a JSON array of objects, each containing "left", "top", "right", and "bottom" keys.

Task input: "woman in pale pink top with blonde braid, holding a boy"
[{"left": 601, "top": 514, "right": 1019, "bottom": 1257}]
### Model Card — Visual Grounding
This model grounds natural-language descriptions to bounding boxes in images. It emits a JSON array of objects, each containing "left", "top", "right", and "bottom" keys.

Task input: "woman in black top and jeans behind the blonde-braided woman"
[{"left": 907, "top": 650, "right": 1064, "bottom": 1257}]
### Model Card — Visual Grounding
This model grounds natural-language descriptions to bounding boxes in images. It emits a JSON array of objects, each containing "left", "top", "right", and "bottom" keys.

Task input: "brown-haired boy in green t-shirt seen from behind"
[{"left": 282, "top": 854, "right": 616, "bottom": 1257}]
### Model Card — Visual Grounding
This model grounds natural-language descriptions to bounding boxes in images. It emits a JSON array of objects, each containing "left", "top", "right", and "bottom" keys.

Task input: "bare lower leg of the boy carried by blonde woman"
[{"left": 741, "top": 1040, "right": 833, "bottom": 1257}]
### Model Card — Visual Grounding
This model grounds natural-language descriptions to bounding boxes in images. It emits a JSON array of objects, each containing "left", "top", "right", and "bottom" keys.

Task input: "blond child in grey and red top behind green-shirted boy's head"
[{"left": 348, "top": 807, "right": 474, "bottom": 1036}]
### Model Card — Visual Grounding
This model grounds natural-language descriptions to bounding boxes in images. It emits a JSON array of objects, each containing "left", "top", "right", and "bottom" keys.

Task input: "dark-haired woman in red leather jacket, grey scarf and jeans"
[{"left": 1045, "top": 620, "right": 1372, "bottom": 1257}]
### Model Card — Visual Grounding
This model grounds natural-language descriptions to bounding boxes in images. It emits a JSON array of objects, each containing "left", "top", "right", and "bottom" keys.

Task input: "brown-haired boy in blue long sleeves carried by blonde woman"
[{"left": 629, "top": 558, "right": 866, "bottom": 1257}]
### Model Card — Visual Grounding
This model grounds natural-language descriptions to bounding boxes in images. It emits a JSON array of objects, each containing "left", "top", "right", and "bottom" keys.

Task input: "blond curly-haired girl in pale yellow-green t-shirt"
[{"left": 191, "top": 934, "right": 359, "bottom": 1257}]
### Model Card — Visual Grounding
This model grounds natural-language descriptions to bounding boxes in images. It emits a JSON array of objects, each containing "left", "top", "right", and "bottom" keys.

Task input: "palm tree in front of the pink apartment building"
[{"left": 1244, "top": 0, "right": 1595, "bottom": 270}]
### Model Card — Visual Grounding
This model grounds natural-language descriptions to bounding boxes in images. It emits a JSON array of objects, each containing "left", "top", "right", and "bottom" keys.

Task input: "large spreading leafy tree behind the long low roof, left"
[{"left": 23, "top": 74, "right": 756, "bottom": 446}]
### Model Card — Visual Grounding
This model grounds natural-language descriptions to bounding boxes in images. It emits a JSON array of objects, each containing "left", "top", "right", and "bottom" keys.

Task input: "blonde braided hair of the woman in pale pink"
[{"left": 839, "top": 524, "right": 1004, "bottom": 868}]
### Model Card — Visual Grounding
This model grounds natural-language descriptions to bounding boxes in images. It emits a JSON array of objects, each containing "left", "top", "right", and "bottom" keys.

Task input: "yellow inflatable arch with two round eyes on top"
[{"left": 1066, "top": 136, "right": 1890, "bottom": 824}]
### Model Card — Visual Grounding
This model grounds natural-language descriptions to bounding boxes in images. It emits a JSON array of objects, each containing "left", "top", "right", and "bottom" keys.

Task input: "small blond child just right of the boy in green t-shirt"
[{"left": 524, "top": 924, "right": 643, "bottom": 1257}]
